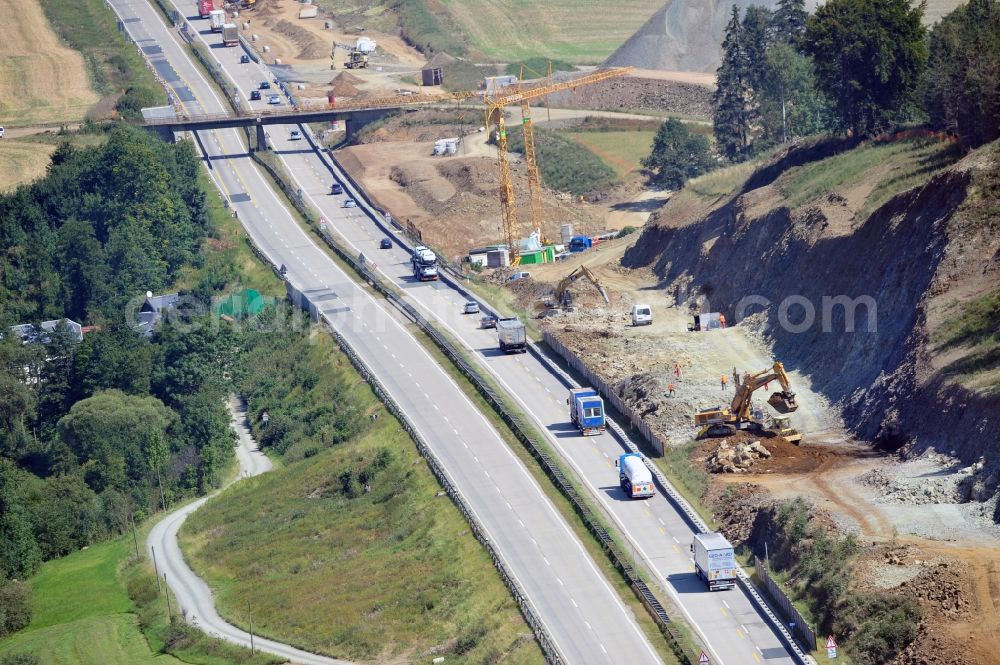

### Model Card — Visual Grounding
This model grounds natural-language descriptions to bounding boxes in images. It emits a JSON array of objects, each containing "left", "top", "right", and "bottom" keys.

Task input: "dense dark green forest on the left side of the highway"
[{"left": 0, "top": 126, "right": 238, "bottom": 636}]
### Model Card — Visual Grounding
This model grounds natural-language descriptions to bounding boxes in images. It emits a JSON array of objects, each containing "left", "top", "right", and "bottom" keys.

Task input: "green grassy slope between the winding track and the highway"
[{"left": 181, "top": 331, "right": 542, "bottom": 663}]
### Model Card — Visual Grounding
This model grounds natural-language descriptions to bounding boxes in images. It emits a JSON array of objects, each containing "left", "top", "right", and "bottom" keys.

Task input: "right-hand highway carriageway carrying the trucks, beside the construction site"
[{"left": 182, "top": 10, "right": 812, "bottom": 665}]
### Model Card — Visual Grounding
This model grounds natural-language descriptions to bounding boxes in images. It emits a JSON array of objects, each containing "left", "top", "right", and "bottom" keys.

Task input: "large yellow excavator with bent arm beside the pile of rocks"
[{"left": 694, "top": 362, "right": 802, "bottom": 439}]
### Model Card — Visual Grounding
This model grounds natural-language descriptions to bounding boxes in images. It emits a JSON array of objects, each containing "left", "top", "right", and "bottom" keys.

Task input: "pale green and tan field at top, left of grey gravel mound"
[{"left": 441, "top": 0, "right": 664, "bottom": 64}]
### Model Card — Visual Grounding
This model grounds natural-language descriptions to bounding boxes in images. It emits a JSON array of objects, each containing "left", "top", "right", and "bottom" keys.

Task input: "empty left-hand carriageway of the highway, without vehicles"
[{"left": 111, "top": 0, "right": 661, "bottom": 663}]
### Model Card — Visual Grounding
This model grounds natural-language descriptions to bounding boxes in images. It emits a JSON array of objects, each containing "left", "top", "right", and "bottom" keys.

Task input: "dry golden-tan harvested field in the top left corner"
[{"left": 0, "top": 0, "right": 99, "bottom": 124}]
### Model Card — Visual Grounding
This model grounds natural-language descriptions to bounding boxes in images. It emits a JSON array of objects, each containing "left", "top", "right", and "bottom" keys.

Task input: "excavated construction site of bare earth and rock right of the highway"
[{"left": 217, "top": 0, "right": 1000, "bottom": 665}]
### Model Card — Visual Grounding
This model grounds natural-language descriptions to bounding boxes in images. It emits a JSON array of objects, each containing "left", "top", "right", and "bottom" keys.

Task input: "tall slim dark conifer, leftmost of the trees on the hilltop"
[{"left": 712, "top": 5, "right": 753, "bottom": 161}]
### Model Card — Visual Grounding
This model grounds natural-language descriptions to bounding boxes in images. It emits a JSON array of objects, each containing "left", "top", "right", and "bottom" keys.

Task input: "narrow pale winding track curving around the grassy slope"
[{"left": 146, "top": 400, "right": 350, "bottom": 665}]
